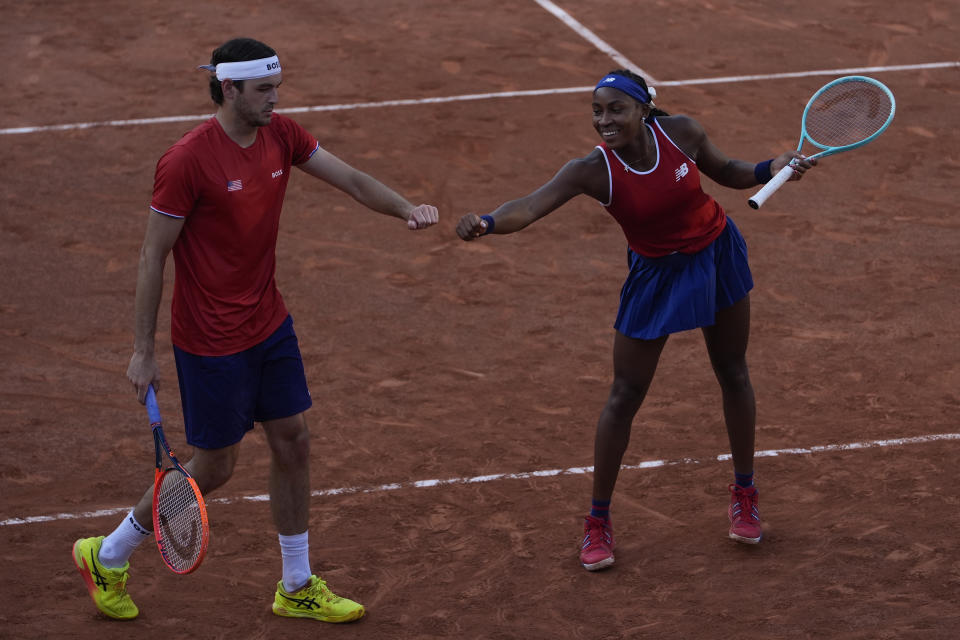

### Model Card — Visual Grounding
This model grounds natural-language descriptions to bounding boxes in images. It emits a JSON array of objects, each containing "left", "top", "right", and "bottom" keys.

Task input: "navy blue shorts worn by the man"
[{"left": 173, "top": 316, "right": 313, "bottom": 449}]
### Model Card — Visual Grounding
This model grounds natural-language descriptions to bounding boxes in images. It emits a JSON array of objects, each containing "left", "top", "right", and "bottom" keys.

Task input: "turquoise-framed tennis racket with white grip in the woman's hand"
[{"left": 749, "top": 76, "right": 897, "bottom": 209}]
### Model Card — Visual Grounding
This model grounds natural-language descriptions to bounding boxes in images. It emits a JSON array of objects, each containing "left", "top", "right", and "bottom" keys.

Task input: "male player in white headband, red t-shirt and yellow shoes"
[{"left": 73, "top": 38, "right": 438, "bottom": 622}]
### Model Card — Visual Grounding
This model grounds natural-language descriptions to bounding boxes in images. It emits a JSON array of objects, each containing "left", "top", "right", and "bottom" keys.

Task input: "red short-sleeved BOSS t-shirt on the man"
[{"left": 150, "top": 113, "right": 319, "bottom": 356}]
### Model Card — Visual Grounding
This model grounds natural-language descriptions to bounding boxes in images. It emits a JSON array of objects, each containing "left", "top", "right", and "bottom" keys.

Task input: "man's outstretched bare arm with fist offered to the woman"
[{"left": 298, "top": 148, "right": 438, "bottom": 229}]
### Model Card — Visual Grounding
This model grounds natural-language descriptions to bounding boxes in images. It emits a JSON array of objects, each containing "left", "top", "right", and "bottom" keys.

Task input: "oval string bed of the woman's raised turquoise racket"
[{"left": 804, "top": 81, "right": 893, "bottom": 147}]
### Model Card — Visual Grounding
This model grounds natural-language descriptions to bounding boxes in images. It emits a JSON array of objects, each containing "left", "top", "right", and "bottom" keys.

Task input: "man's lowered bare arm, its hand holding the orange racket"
[{"left": 127, "top": 211, "right": 184, "bottom": 403}]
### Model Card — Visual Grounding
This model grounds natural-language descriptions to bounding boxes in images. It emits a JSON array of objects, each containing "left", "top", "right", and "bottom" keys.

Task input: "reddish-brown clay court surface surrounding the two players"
[{"left": 0, "top": 0, "right": 960, "bottom": 640}]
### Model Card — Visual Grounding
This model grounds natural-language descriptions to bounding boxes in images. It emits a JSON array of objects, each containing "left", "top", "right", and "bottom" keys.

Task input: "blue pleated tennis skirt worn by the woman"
[{"left": 613, "top": 217, "right": 753, "bottom": 340}]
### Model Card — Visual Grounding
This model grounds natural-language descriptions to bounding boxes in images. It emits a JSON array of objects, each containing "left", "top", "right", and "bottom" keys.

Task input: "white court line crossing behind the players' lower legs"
[{"left": 0, "top": 433, "right": 960, "bottom": 527}]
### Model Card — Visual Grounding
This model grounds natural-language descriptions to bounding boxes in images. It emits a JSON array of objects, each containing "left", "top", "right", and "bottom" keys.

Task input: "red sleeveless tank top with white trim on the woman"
[{"left": 598, "top": 120, "right": 727, "bottom": 258}]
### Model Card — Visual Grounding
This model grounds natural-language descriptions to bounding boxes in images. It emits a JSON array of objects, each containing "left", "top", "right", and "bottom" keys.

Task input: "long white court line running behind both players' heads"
[{"left": 0, "top": 61, "right": 960, "bottom": 135}]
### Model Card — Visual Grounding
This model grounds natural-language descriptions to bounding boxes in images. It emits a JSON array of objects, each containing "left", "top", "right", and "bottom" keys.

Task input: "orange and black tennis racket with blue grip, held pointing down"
[{"left": 146, "top": 385, "right": 210, "bottom": 574}]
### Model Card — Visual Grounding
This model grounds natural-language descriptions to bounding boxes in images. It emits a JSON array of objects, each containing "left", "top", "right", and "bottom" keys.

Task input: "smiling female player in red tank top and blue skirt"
[{"left": 457, "top": 70, "right": 816, "bottom": 571}]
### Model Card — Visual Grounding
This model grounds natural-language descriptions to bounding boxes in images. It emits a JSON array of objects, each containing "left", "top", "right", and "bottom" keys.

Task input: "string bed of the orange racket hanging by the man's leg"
[{"left": 156, "top": 469, "right": 204, "bottom": 571}]
